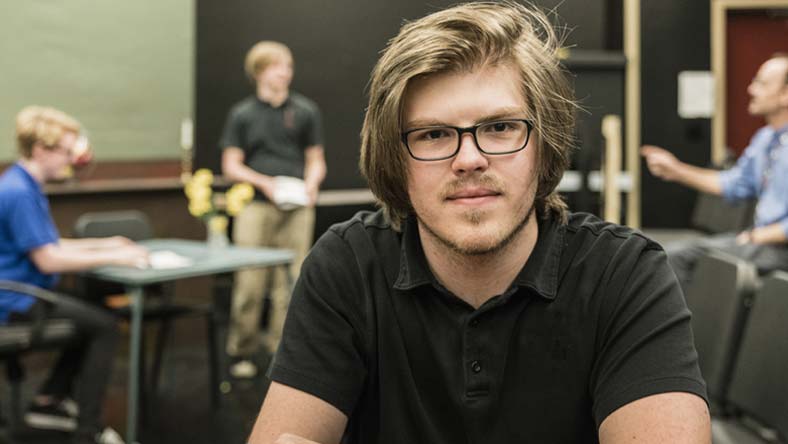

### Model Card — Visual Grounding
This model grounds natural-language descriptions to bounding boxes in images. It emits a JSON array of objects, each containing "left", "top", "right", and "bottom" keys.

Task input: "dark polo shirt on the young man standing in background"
[{"left": 219, "top": 91, "right": 323, "bottom": 198}]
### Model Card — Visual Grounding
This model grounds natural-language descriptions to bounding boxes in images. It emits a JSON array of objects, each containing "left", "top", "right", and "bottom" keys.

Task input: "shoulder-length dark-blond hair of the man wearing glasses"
[{"left": 359, "top": 1, "right": 576, "bottom": 229}]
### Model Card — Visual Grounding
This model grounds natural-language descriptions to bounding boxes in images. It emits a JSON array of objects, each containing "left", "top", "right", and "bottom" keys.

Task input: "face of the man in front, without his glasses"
[{"left": 402, "top": 66, "right": 537, "bottom": 255}]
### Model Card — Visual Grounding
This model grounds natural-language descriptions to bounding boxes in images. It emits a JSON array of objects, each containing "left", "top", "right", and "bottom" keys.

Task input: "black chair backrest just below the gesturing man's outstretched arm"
[{"left": 692, "top": 193, "right": 755, "bottom": 233}]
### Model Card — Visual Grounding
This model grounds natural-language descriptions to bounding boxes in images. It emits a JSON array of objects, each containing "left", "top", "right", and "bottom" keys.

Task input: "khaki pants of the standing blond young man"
[{"left": 227, "top": 201, "right": 315, "bottom": 357}]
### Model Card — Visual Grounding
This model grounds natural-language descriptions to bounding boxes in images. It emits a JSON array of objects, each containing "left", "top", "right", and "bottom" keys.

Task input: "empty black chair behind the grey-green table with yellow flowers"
[{"left": 74, "top": 210, "right": 220, "bottom": 407}]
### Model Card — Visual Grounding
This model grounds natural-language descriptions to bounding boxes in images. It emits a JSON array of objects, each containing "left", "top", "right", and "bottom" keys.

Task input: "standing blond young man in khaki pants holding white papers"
[{"left": 220, "top": 41, "right": 326, "bottom": 378}]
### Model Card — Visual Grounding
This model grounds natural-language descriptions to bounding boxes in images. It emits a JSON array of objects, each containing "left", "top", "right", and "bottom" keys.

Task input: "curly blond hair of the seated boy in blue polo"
[{"left": 16, "top": 105, "right": 82, "bottom": 159}]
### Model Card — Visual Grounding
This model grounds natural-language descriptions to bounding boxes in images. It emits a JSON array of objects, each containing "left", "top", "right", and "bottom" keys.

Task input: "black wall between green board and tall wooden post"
[{"left": 195, "top": 0, "right": 621, "bottom": 189}]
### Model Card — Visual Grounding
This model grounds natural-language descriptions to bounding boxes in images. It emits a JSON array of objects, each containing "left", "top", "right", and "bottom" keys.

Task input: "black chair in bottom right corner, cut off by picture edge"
[{"left": 712, "top": 271, "right": 788, "bottom": 444}]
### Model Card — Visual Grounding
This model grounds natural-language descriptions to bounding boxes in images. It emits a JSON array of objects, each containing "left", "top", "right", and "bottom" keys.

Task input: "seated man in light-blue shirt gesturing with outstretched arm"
[{"left": 641, "top": 54, "right": 788, "bottom": 291}]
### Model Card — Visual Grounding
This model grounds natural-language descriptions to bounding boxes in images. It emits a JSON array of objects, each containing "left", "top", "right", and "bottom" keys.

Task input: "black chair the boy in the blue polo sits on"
[{"left": 0, "top": 280, "right": 77, "bottom": 430}]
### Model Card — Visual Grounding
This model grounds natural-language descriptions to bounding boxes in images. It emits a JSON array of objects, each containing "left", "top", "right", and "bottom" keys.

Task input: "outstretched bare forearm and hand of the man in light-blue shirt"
[{"left": 640, "top": 145, "right": 722, "bottom": 196}]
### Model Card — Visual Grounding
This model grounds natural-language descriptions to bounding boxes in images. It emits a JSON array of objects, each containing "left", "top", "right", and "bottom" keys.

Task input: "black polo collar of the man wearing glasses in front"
[{"left": 394, "top": 212, "right": 565, "bottom": 300}]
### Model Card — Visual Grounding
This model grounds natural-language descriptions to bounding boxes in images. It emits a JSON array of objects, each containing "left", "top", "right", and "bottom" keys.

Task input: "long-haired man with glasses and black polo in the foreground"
[{"left": 250, "top": 2, "right": 710, "bottom": 444}]
